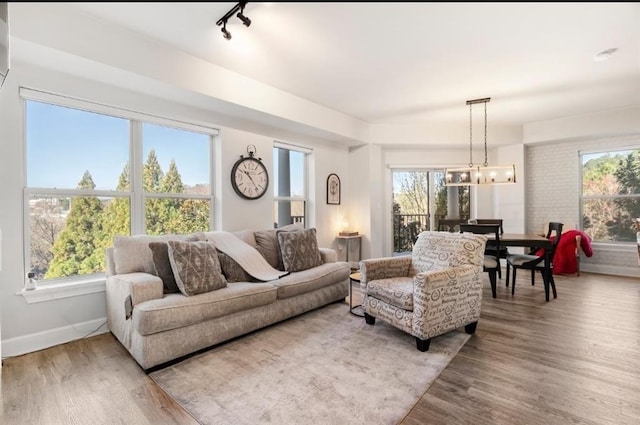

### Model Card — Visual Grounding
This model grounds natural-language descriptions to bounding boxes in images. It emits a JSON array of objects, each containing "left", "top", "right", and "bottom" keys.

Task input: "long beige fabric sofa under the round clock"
[{"left": 106, "top": 229, "right": 350, "bottom": 370}]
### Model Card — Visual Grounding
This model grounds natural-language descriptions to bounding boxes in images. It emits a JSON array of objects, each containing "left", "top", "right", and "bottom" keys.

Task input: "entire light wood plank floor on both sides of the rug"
[{"left": 0, "top": 273, "right": 640, "bottom": 425}]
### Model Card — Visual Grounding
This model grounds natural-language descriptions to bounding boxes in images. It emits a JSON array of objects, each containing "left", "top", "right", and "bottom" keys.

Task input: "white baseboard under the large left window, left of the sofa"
[{"left": 1, "top": 317, "right": 109, "bottom": 358}]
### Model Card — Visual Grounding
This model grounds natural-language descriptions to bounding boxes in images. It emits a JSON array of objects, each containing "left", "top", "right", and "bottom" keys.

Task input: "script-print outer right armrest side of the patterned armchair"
[{"left": 412, "top": 265, "right": 484, "bottom": 339}]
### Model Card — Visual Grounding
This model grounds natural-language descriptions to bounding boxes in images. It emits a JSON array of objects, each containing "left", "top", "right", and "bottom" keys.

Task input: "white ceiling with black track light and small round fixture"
[{"left": 48, "top": 2, "right": 640, "bottom": 132}]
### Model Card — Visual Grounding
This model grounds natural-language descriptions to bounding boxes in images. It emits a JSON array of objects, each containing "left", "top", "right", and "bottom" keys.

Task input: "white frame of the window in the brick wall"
[{"left": 578, "top": 144, "right": 640, "bottom": 245}]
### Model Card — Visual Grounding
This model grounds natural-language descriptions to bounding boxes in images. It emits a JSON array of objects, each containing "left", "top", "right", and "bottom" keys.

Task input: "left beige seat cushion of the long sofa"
[{"left": 133, "top": 282, "right": 276, "bottom": 335}]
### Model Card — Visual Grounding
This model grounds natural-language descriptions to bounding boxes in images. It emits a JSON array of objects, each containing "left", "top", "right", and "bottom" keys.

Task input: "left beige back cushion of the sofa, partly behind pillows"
[{"left": 113, "top": 232, "right": 204, "bottom": 275}]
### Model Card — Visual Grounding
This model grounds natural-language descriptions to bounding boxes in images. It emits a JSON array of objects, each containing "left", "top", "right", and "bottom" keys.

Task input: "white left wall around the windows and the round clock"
[{"left": 0, "top": 62, "right": 349, "bottom": 356}]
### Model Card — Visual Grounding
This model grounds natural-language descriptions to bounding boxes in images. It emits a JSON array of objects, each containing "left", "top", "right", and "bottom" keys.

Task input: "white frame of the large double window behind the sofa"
[{"left": 18, "top": 87, "right": 219, "bottom": 294}]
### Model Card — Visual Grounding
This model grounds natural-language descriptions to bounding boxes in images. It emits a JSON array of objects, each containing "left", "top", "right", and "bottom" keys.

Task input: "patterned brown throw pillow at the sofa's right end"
[{"left": 278, "top": 229, "right": 322, "bottom": 272}]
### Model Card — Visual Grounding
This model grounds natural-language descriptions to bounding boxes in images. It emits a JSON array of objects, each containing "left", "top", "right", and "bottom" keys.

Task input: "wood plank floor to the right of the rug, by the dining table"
[{"left": 402, "top": 273, "right": 640, "bottom": 425}]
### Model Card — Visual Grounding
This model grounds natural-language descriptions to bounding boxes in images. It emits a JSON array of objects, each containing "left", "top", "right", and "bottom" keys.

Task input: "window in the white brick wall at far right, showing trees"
[{"left": 580, "top": 148, "right": 640, "bottom": 243}]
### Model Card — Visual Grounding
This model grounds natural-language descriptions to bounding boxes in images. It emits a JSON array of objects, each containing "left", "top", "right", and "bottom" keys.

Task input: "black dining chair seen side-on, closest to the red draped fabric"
[{"left": 507, "top": 222, "right": 563, "bottom": 298}]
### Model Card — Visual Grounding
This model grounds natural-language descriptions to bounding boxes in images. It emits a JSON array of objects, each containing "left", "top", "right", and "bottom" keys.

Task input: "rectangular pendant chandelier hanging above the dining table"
[{"left": 444, "top": 97, "right": 516, "bottom": 186}]
